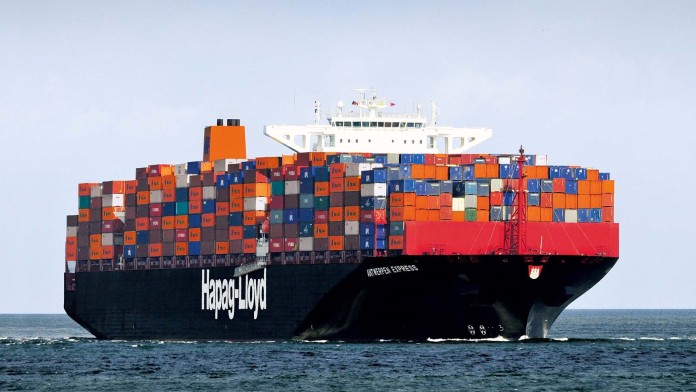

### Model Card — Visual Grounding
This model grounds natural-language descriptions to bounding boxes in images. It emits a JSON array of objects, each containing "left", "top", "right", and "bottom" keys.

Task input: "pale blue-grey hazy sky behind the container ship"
[{"left": 0, "top": 0, "right": 696, "bottom": 313}]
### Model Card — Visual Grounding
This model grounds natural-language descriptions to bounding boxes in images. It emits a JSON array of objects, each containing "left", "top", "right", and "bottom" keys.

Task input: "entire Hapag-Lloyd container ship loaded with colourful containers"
[{"left": 64, "top": 90, "right": 619, "bottom": 341}]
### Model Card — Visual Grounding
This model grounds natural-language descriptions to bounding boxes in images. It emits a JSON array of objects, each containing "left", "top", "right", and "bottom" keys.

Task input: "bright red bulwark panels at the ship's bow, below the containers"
[{"left": 403, "top": 221, "right": 619, "bottom": 257}]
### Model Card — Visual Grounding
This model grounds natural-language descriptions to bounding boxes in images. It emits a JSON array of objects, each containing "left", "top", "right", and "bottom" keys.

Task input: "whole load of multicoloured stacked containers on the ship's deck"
[{"left": 66, "top": 153, "right": 614, "bottom": 267}]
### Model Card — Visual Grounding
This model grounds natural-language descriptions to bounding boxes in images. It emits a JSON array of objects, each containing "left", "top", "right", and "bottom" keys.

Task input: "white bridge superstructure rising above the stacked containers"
[{"left": 264, "top": 89, "right": 493, "bottom": 154}]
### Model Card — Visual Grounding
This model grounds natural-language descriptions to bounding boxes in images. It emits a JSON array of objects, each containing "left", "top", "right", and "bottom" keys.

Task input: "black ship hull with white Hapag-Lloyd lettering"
[{"left": 64, "top": 255, "right": 617, "bottom": 341}]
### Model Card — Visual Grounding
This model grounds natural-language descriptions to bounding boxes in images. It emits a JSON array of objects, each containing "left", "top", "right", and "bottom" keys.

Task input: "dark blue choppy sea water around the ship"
[{"left": 0, "top": 310, "right": 696, "bottom": 392}]
